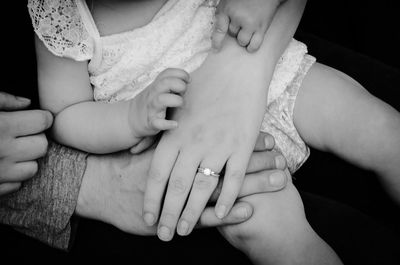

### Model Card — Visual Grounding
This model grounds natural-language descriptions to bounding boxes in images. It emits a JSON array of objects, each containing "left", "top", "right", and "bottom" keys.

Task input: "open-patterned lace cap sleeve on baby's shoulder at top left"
[{"left": 28, "top": 0, "right": 94, "bottom": 61}]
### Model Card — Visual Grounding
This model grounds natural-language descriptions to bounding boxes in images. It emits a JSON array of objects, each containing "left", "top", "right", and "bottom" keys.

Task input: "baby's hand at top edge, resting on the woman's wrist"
[{"left": 212, "top": 0, "right": 285, "bottom": 52}]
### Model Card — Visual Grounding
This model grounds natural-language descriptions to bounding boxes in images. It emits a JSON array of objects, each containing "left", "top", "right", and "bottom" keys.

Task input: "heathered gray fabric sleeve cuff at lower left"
[{"left": 0, "top": 143, "right": 87, "bottom": 250}]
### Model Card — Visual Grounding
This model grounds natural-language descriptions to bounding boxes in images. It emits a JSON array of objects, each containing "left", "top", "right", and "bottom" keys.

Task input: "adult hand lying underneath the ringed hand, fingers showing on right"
[{"left": 76, "top": 134, "right": 287, "bottom": 235}]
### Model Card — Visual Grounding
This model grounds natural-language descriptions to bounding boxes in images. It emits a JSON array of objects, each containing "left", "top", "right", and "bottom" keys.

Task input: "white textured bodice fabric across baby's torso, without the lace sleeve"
[{"left": 89, "top": 0, "right": 215, "bottom": 102}]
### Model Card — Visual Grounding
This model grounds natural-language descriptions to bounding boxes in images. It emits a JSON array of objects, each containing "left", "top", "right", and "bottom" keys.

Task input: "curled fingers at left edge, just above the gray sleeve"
[{"left": 0, "top": 92, "right": 53, "bottom": 196}]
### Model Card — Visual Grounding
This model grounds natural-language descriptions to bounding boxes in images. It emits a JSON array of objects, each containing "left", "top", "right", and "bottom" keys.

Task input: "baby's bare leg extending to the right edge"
[{"left": 294, "top": 64, "right": 400, "bottom": 203}]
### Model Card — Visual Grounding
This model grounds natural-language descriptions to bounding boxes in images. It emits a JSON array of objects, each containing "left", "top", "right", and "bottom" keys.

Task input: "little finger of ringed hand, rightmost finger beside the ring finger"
[{"left": 215, "top": 152, "right": 249, "bottom": 218}]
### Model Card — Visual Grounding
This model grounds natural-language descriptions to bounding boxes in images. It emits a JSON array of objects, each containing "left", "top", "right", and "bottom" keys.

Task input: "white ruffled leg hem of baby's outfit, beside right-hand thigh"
[{"left": 261, "top": 54, "right": 315, "bottom": 174}]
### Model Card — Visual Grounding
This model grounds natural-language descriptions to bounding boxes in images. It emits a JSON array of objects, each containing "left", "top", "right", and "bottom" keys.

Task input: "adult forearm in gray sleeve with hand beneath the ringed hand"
[{"left": 0, "top": 135, "right": 286, "bottom": 249}]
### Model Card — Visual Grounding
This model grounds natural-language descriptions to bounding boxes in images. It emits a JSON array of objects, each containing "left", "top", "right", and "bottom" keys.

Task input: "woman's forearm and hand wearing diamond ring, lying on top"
[{"left": 144, "top": 0, "right": 305, "bottom": 240}]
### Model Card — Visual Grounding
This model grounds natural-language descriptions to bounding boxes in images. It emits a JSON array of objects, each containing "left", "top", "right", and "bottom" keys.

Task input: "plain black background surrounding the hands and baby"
[{"left": 0, "top": 0, "right": 400, "bottom": 264}]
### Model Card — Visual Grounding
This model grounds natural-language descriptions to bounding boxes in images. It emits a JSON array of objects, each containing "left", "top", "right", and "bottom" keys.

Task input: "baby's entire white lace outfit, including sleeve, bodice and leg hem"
[{"left": 28, "top": 0, "right": 315, "bottom": 173}]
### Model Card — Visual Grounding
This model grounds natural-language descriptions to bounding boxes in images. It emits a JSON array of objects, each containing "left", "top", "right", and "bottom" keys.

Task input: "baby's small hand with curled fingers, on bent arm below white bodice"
[{"left": 129, "top": 68, "right": 190, "bottom": 138}]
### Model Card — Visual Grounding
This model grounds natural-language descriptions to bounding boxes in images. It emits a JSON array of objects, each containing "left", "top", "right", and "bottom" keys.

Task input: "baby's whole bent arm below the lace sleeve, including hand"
[{"left": 36, "top": 38, "right": 189, "bottom": 153}]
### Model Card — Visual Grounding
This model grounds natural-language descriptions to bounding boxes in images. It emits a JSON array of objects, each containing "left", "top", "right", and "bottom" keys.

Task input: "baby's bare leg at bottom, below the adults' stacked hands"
[{"left": 220, "top": 173, "right": 341, "bottom": 265}]
